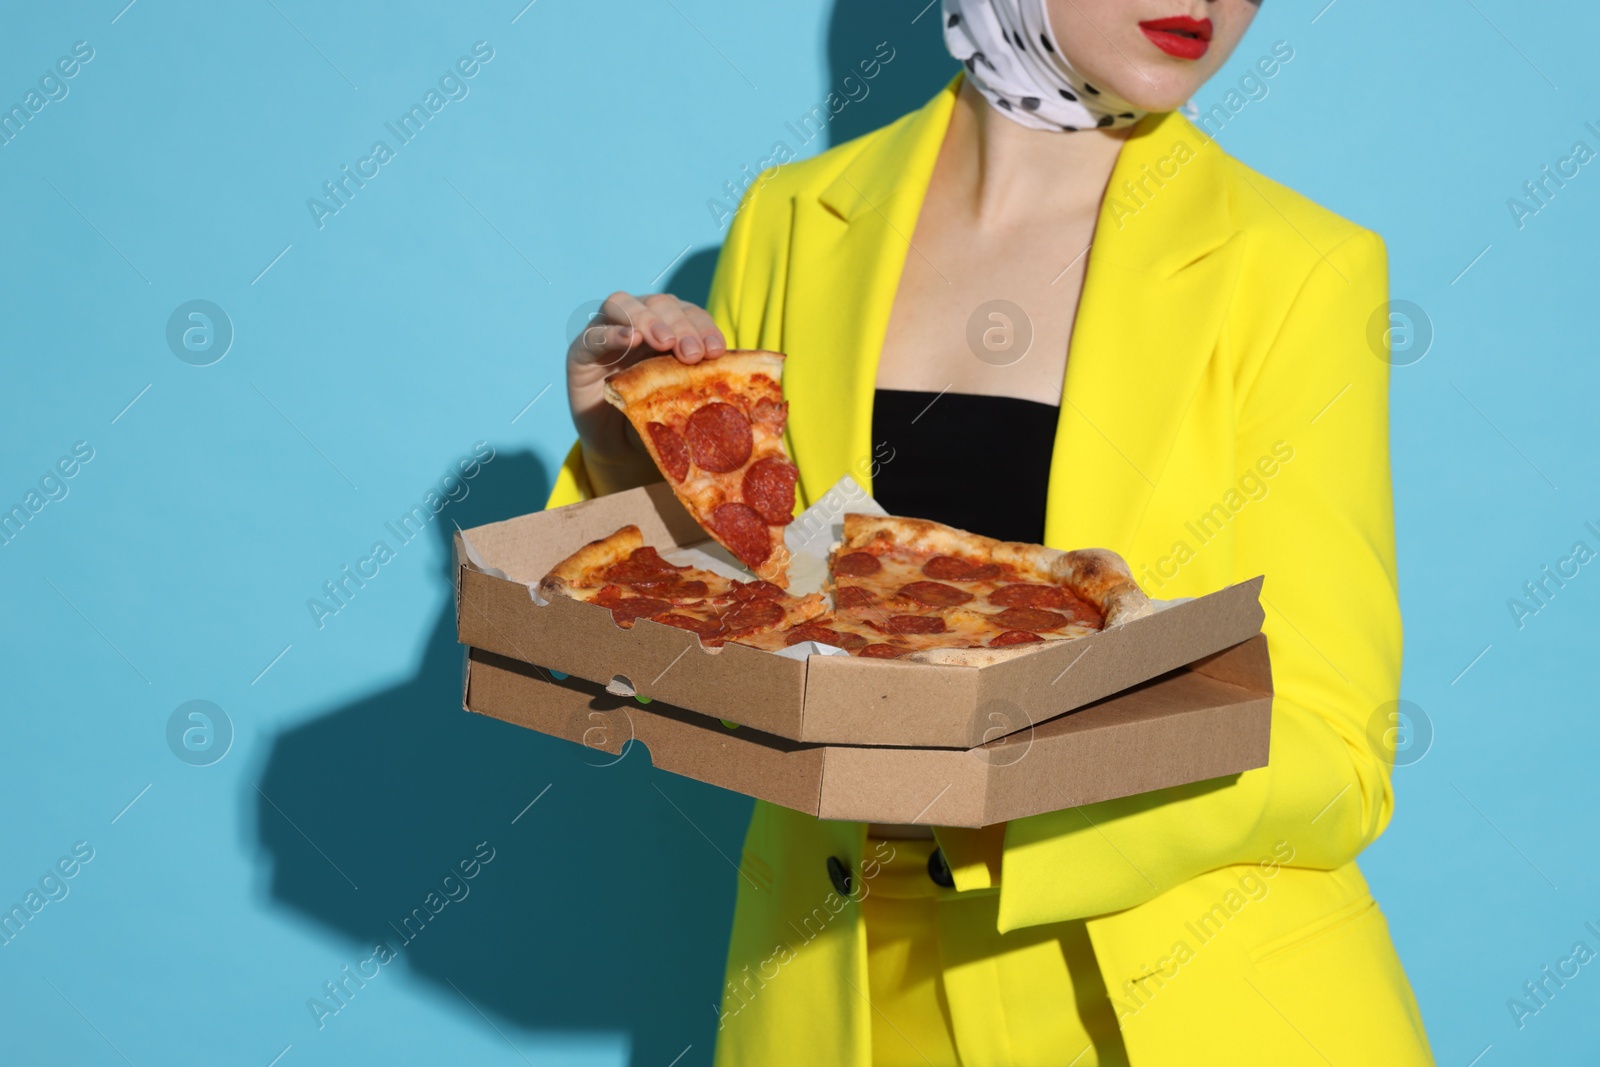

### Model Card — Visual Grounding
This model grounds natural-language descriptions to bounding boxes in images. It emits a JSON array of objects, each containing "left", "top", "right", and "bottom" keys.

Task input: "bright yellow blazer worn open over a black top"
[{"left": 550, "top": 78, "right": 1432, "bottom": 1067}]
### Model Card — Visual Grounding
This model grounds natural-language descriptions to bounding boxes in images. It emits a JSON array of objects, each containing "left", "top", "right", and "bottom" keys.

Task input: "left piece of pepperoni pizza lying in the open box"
[{"left": 539, "top": 526, "right": 827, "bottom": 648}]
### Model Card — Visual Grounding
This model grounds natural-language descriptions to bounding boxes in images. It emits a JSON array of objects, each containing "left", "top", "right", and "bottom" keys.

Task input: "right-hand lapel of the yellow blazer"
[{"left": 1045, "top": 112, "right": 1238, "bottom": 553}]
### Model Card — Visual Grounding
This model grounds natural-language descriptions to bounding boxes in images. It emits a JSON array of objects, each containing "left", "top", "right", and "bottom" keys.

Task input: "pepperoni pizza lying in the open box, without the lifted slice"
[{"left": 539, "top": 514, "right": 1152, "bottom": 667}]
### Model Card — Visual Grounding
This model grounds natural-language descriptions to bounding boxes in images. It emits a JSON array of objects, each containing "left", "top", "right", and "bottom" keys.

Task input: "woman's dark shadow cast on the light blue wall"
[{"left": 246, "top": 8, "right": 955, "bottom": 1067}]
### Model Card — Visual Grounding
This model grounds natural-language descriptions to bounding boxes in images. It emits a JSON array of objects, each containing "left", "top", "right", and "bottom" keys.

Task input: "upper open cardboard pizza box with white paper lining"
[{"left": 456, "top": 478, "right": 1264, "bottom": 749}]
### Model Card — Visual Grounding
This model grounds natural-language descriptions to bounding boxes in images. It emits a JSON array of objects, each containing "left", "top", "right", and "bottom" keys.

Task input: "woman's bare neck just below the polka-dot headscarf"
[{"left": 941, "top": 80, "right": 1133, "bottom": 222}]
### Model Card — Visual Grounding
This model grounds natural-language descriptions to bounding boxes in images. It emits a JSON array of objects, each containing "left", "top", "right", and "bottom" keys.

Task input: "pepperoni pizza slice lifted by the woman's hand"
[{"left": 605, "top": 350, "right": 798, "bottom": 589}]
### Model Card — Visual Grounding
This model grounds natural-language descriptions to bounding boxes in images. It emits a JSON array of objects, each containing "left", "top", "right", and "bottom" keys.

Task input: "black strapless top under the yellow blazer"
[{"left": 872, "top": 389, "right": 1061, "bottom": 544}]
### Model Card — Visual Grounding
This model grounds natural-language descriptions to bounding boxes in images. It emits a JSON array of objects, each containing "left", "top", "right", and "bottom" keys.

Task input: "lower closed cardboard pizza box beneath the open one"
[{"left": 462, "top": 635, "right": 1272, "bottom": 827}]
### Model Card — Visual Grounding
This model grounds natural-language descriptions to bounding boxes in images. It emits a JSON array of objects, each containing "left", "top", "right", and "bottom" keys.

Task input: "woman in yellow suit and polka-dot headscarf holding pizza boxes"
[{"left": 550, "top": 0, "right": 1432, "bottom": 1067}]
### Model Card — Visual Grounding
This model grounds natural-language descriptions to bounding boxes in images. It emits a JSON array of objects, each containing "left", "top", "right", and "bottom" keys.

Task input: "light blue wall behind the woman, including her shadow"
[{"left": 0, "top": 0, "right": 1600, "bottom": 1067}]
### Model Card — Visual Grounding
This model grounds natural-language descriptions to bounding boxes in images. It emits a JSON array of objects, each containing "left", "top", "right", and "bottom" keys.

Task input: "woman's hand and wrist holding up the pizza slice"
[{"left": 566, "top": 293, "right": 728, "bottom": 496}]
